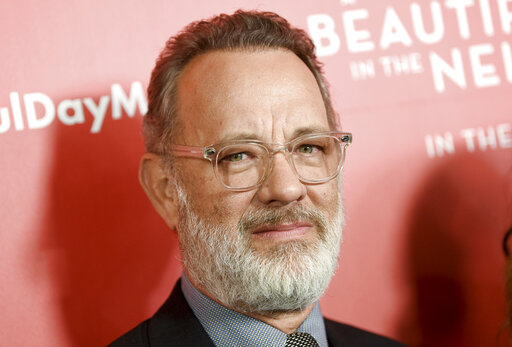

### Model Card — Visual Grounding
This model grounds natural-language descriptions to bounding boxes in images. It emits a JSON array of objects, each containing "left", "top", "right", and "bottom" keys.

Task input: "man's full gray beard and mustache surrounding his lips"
[{"left": 178, "top": 187, "right": 343, "bottom": 316}]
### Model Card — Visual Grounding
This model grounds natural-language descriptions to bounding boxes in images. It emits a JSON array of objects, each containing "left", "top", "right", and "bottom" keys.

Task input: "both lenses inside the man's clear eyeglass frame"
[{"left": 216, "top": 136, "right": 342, "bottom": 188}]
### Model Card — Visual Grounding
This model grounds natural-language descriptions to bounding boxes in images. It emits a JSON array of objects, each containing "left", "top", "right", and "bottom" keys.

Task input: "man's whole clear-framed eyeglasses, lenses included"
[{"left": 171, "top": 131, "right": 352, "bottom": 191}]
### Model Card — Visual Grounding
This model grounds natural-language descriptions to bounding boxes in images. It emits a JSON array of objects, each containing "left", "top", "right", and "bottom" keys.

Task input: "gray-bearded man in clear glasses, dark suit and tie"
[{"left": 112, "top": 11, "right": 399, "bottom": 347}]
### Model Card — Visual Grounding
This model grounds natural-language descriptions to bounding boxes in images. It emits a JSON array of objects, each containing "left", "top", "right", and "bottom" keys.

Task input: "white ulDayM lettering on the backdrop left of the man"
[{"left": 0, "top": 82, "right": 148, "bottom": 134}]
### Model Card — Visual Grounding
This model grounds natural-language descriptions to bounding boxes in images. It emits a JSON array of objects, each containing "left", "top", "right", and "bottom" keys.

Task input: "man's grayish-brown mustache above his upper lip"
[{"left": 238, "top": 206, "right": 328, "bottom": 236}]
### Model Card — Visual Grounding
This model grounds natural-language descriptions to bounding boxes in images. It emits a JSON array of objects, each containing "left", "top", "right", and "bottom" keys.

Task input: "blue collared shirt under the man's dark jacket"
[{"left": 181, "top": 274, "right": 328, "bottom": 347}]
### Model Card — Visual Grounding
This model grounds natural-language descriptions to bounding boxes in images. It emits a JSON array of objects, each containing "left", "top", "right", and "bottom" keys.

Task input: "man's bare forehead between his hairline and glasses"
[{"left": 177, "top": 50, "right": 329, "bottom": 145}]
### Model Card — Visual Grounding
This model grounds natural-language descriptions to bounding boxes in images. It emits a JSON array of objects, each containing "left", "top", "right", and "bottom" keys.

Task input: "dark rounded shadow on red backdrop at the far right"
[{"left": 399, "top": 151, "right": 512, "bottom": 347}]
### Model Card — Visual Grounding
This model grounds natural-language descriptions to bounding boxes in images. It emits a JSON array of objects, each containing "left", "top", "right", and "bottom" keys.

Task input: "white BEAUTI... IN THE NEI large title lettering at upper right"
[{"left": 307, "top": 0, "right": 512, "bottom": 92}]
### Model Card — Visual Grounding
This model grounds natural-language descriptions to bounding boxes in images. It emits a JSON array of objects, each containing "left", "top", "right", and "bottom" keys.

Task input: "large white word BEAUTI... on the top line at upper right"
[{"left": 307, "top": 0, "right": 512, "bottom": 56}]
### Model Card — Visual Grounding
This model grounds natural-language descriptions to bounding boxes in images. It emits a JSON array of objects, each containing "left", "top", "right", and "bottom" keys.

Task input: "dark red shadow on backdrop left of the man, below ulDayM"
[{"left": 39, "top": 99, "right": 180, "bottom": 346}]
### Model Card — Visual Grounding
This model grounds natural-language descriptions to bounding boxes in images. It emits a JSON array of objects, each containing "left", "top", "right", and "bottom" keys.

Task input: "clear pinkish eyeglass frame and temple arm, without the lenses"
[{"left": 171, "top": 131, "right": 352, "bottom": 191}]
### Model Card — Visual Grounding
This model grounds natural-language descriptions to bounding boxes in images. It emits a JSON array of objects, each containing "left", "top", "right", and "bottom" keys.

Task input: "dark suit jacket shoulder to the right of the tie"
[{"left": 324, "top": 318, "right": 404, "bottom": 347}]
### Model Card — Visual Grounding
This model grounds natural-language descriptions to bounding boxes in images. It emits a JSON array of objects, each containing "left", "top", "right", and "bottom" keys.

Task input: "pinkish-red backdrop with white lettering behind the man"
[{"left": 0, "top": 0, "right": 512, "bottom": 346}]
